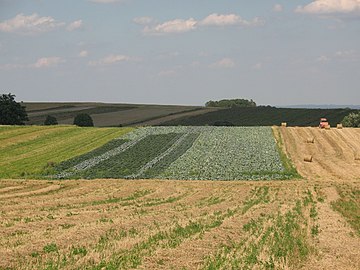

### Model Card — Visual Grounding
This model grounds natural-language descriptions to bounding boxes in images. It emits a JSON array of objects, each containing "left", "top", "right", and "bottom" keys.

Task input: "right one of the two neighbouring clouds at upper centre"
[{"left": 199, "top": 13, "right": 263, "bottom": 26}]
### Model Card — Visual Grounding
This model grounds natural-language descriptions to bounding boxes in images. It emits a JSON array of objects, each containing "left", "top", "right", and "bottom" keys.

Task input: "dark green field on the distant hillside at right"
[{"left": 161, "top": 106, "right": 357, "bottom": 126}]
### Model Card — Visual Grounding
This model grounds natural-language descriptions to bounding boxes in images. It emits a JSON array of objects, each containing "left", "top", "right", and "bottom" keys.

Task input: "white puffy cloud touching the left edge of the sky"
[{"left": 0, "top": 13, "right": 65, "bottom": 34}]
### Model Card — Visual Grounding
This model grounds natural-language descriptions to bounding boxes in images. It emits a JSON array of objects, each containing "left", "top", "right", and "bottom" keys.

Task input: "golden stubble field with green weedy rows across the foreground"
[{"left": 0, "top": 180, "right": 360, "bottom": 269}]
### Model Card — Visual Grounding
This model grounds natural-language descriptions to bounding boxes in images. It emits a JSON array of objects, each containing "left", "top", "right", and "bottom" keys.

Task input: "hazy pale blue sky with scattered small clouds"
[{"left": 0, "top": 0, "right": 360, "bottom": 106}]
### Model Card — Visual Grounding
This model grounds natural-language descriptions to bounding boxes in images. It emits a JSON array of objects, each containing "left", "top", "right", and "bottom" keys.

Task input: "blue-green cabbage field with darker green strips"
[{"left": 55, "top": 126, "right": 292, "bottom": 180}]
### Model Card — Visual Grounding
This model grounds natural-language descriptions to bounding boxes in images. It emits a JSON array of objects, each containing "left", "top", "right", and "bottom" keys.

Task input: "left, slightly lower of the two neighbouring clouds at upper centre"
[{"left": 144, "top": 18, "right": 197, "bottom": 35}]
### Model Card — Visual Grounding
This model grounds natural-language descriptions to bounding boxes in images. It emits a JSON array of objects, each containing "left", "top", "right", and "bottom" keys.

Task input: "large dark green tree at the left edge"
[{"left": 0, "top": 93, "right": 29, "bottom": 125}]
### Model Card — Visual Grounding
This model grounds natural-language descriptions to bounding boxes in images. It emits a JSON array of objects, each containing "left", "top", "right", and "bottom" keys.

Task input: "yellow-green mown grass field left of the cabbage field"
[{"left": 0, "top": 126, "right": 132, "bottom": 178}]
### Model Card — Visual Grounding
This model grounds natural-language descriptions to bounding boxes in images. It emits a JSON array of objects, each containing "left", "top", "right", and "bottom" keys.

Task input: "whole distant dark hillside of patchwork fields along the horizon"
[{"left": 24, "top": 102, "right": 357, "bottom": 127}]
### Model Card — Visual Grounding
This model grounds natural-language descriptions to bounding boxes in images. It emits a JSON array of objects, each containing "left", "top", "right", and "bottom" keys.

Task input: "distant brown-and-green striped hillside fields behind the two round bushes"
[{"left": 24, "top": 102, "right": 218, "bottom": 127}]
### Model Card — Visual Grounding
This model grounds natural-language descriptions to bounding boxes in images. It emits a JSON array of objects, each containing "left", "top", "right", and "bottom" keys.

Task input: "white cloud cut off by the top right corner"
[{"left": 295, "top": 0, "right": 360, "bottom": 14}]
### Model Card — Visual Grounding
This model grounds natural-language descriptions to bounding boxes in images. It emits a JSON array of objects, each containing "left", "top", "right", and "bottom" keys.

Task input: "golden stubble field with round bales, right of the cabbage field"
[{"left": 281, "top": 127, "right": 360, "bottom": 181}]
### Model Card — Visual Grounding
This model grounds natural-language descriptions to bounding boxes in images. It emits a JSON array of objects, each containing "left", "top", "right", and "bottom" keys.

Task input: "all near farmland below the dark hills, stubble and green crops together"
[{"left": 0, "top": 126, "right": 360, "bottom": 269}]
